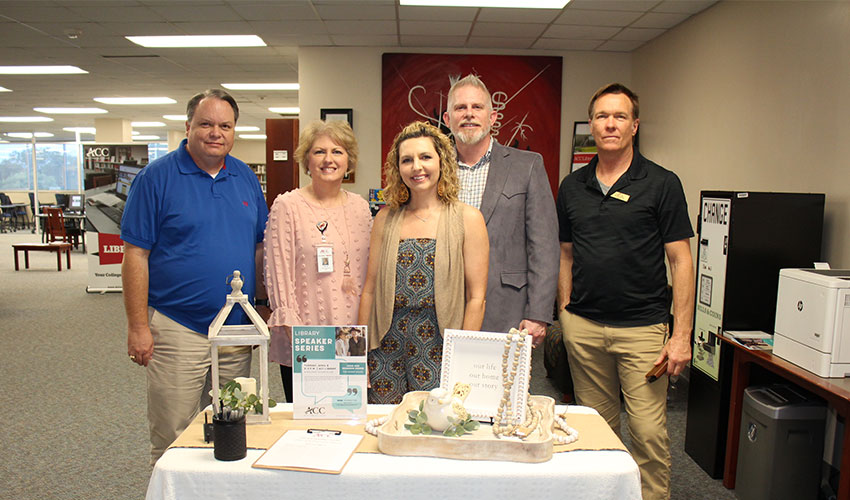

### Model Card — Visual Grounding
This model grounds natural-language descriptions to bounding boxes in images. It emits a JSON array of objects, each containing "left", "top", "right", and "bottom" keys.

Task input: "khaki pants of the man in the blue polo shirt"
[{"left": 146, "top": 307, "right": 251, "bottom": 465}]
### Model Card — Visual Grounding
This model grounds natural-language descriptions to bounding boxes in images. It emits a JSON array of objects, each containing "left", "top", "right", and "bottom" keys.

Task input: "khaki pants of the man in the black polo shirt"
[{"left": 559, "top": 310, "right": 671, "bottom": 500}]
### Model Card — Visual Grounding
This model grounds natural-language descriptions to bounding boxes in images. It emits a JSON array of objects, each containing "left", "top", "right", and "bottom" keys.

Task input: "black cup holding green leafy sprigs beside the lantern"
[{"left": 213, "top": 380, "right": 277, "bottom": 461}]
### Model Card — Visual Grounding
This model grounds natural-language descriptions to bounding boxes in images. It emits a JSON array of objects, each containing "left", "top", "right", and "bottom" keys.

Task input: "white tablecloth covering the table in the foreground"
[{"left": 147, "top": 405, "right": 640, "bottom": 500}]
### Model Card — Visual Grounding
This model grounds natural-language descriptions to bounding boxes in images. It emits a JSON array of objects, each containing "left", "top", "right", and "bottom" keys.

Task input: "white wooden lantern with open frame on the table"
[{"left": 207, "top": 270, "right": 271, "bottom": 424}]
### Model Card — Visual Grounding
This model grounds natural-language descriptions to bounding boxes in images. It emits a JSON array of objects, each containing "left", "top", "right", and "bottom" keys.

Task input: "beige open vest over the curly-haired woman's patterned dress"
[{"left": 369, "top": 203, "right": 466, "bottom": 350}]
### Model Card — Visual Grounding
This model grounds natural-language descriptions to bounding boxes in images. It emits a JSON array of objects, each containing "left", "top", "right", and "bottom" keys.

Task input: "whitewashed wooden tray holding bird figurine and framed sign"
[{"left": 378, "top": 391, "right": 555, "bottom": 463}]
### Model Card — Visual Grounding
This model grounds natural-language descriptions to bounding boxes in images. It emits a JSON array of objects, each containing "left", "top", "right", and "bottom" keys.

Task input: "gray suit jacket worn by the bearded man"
[{"left": 481, "top": 143, "right": 560, "bottom": 332}]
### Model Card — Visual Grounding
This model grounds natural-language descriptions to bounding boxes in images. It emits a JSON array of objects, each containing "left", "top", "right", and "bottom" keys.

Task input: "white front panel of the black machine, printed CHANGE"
[{"left": 693, "top": 198, "right": 732, "bottom": 380}]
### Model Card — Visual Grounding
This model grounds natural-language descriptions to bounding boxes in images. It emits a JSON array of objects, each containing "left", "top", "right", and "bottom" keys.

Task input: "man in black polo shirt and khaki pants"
[{"left": 557, "top": 83, "right": 694, "bottom": 500}]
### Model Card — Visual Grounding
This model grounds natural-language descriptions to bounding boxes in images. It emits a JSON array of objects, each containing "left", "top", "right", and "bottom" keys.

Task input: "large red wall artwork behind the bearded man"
[{"left": 381, "top": 54, "right": 561, "bottom": 194}]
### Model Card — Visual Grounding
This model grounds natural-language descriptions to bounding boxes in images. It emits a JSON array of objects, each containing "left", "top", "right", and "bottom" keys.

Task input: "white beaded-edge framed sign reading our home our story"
[{"left": 440, "top": 329, "right": 531, "bottom": 424}]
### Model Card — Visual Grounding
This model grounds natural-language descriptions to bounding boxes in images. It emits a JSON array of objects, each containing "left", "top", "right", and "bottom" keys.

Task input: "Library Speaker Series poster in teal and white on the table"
[{"left": 292, "top": 325, "right": 368, "bottom": 419}]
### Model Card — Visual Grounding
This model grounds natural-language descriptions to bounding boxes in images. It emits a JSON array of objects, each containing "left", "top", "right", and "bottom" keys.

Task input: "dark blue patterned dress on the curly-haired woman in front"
[{"left": 369, "top": 238, "right": 443, "bottom": 404}]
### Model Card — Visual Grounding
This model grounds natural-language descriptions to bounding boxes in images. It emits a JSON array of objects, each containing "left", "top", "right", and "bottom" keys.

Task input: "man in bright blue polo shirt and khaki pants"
[{"left": 121, "top": 89, "right": 268, "bottom": 465}]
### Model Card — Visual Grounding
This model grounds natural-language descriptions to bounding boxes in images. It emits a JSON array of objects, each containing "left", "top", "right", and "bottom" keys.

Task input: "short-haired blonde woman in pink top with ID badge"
[{"left": 263, "top": 121, "right": 372, "bottom": 402}]
